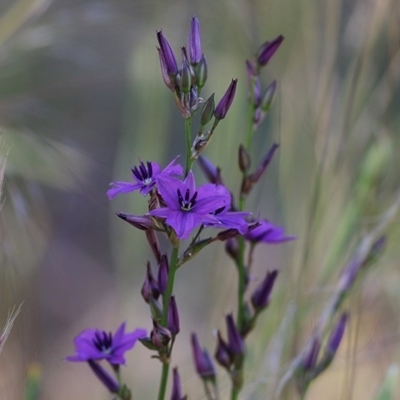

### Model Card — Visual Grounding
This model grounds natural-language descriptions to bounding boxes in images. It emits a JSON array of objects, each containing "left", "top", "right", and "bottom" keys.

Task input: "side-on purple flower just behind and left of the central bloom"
[{"left": 107, "top": 157, "right": 183, "bottom": 200}]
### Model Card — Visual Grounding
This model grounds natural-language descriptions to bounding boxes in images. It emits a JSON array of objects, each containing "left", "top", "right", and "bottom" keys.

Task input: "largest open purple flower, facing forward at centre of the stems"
[{"left": 150, "top": 171, "right": 231, "bottom": 239}]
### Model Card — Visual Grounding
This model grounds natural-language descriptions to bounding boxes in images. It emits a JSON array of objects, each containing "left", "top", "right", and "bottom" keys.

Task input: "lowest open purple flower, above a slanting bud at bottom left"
[{"left": 66, "top": 322, "right": 146, "bottom": 365}]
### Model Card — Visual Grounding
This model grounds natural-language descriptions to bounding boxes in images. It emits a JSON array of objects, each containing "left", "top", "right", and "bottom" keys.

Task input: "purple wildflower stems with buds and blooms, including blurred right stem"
[{"left": 67, "top": 17, "right": 396, "bottom": 400}]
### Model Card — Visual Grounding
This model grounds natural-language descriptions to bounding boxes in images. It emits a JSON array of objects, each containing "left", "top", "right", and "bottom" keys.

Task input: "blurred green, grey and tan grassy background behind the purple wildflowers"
[{"left": 0, "top": 0, "right": 400, "bottom": 400}]
